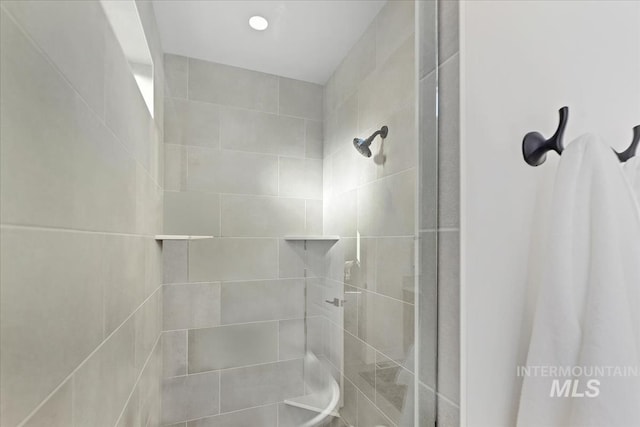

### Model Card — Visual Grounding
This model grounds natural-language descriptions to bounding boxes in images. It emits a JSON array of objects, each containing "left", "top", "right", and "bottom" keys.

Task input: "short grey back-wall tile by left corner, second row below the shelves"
[{"left": 162, "top": 283, "right": 221, "bottom": 331}]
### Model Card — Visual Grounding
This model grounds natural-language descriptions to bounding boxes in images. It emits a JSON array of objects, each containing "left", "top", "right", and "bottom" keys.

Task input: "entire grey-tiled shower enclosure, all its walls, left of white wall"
[{"left": 0, "top": 1, "right": 459, "bottom": 427}]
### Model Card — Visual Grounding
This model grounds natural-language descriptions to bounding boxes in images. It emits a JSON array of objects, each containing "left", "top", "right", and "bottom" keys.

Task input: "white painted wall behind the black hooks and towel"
[{"left": 460, "top": 0, "right": 640, "bottom": 427}]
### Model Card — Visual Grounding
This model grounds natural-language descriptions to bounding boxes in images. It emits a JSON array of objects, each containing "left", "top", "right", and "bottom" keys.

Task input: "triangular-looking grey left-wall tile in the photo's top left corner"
[{"left": 2, "top": 1, "right": 106, "bottom": 116}]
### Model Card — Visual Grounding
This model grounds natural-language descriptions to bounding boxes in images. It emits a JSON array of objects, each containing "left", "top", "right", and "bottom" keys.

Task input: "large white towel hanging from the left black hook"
[{"left": 518, "top": 135, "right": 640, "bottom": 427}]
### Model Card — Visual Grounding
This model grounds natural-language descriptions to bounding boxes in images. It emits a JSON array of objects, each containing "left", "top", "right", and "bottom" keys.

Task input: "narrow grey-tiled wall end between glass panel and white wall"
[{"left": 418, "top": 0, "right": 460, "bottom": 426}]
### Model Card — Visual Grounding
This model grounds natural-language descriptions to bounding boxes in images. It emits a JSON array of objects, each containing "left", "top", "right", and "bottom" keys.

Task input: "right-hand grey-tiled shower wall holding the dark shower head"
[{"left": 323, "top": 1, "right": 418, "bottom": 427}]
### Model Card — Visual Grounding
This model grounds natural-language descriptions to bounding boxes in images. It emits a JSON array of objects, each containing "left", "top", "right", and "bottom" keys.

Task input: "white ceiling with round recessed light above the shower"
[{"left": 153, "top": 0, "right": 386, "bottom": 84}]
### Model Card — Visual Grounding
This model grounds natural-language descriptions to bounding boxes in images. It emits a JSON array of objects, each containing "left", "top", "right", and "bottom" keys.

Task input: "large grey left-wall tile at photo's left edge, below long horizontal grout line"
[{"left": 0, "top": 228, "right": 103, "bottom": 425}]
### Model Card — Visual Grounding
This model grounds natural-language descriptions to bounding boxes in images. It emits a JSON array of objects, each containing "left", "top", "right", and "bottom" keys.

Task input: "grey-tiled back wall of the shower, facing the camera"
[{"left": 163, "top": 55, "right": 323, "bottom": 427}]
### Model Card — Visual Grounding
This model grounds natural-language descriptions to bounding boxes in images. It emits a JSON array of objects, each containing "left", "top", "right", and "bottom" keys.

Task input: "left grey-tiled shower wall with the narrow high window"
[{"left": 0, "top": 1, "right": 163, "bottom": 427}]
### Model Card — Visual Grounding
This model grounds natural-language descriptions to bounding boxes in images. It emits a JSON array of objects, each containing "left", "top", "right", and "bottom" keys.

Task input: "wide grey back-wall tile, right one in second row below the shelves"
[{"left": 221, "top": 279, "right": 304, "bottom": 324}]
